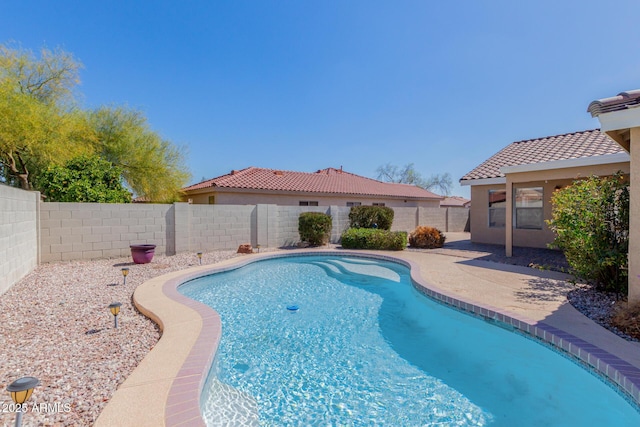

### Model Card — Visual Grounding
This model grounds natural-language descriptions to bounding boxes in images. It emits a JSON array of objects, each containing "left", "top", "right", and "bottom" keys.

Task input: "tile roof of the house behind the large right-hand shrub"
[{"left": 460, "top": 129, "right": 624, "bottom": 181}]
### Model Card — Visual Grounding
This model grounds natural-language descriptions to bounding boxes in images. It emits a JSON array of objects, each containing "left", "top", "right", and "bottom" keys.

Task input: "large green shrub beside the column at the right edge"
[{"left": 547, "top": 172, "right": 629, "bottom": 294}]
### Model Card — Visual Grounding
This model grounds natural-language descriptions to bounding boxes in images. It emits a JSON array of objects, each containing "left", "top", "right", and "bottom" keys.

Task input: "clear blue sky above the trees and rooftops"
[{"left": 0, "top": 0, "right": 640, "bottom": 196}]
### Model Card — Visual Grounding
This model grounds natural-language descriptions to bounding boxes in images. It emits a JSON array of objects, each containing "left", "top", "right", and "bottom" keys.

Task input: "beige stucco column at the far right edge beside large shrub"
[{"left": 628, "top": 127, "right": 640, "bottom": 302}]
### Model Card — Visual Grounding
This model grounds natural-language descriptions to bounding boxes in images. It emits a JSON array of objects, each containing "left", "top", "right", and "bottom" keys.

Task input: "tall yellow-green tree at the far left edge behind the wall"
[{"left": 0, "top": 45, "right": 84, "bottom": 189}]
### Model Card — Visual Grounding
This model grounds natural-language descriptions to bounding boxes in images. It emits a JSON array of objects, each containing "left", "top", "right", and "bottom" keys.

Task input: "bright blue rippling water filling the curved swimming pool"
[{"left": 180, "top": 256, "right": 640, "bottom": 426}]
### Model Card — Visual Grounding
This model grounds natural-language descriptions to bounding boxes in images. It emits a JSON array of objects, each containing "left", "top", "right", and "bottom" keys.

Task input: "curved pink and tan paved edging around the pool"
[{"left": 96, "top": 249, "right": 640, "bottom": 426}]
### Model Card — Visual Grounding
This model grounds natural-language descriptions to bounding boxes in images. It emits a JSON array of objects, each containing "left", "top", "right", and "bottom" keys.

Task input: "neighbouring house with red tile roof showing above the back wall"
[{"left": 182, "top": 167, "right": 444, "bottom": 208}]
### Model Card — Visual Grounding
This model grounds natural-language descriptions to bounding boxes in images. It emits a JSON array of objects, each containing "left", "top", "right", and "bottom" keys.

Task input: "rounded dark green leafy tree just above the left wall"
[{"left": 37, "top": 156, "right": 131, "bottom": 203}]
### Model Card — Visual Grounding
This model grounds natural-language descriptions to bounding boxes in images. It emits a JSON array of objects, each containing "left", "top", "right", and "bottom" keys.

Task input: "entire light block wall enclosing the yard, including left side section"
[{"left": 0, "top": 185, "right": 469, "bottom": 293}]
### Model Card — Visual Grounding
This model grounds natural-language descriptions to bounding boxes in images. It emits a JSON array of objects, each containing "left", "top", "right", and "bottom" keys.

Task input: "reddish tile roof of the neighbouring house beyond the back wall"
[{"left": 182, "top": 166, "right": 442, "bottom": 199}]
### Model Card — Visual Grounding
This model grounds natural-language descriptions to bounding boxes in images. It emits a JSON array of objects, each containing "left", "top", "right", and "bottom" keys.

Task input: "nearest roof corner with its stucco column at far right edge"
[{"left": 587, "top": 90, "right": 640, "bottom": 302}]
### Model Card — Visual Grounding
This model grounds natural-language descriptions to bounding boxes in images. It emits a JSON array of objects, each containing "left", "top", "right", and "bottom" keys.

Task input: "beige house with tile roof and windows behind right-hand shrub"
[{"left": 460, "top": 129, "right": 630, "bottom": 256}]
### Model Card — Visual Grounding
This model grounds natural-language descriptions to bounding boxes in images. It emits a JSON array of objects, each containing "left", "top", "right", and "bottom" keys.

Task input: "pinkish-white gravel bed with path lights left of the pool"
[{"left": 0, "top": 251, "right": 241, "bottom": 426}]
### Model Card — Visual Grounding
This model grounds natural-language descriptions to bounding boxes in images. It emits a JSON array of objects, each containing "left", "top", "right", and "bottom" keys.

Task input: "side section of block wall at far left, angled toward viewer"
[{"left": 0, "top": 184, "right": 40, "bottom": 295}]
